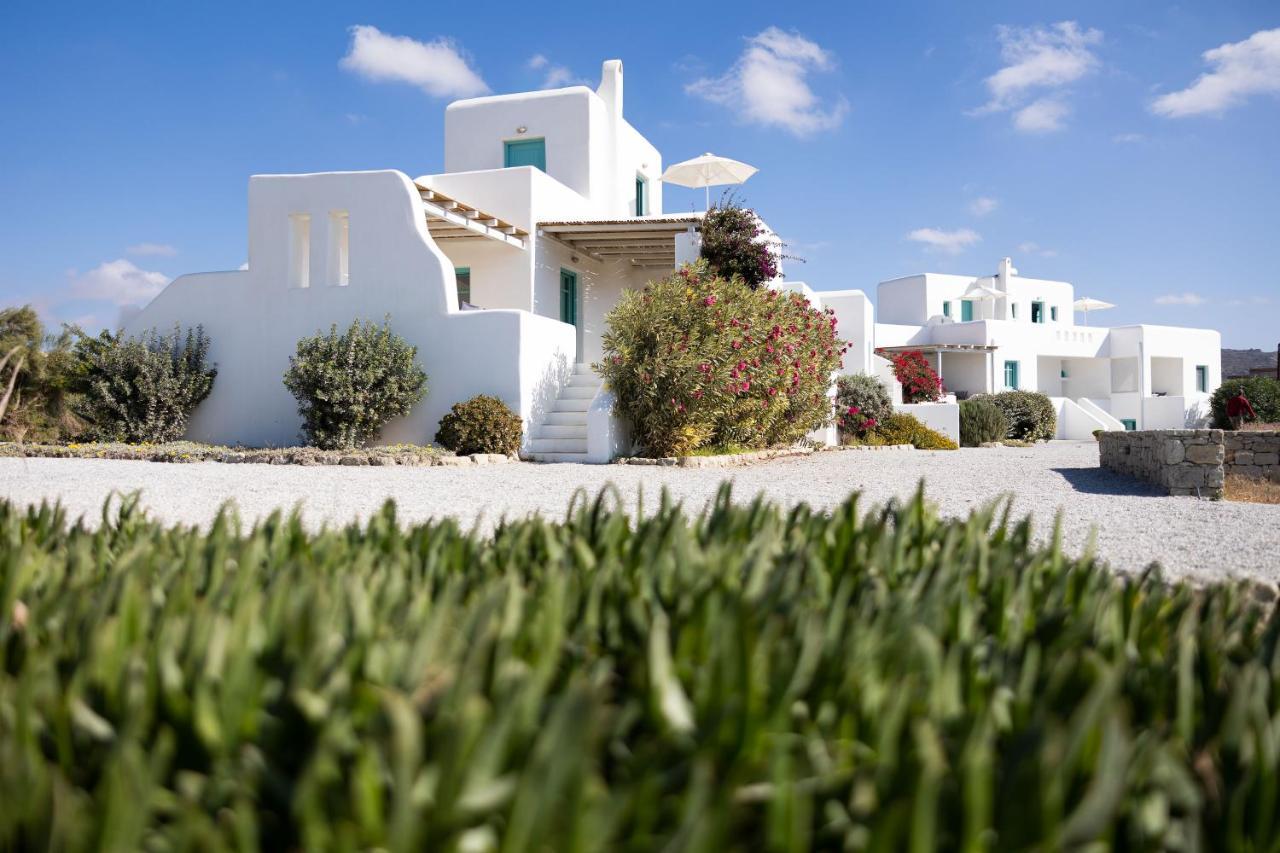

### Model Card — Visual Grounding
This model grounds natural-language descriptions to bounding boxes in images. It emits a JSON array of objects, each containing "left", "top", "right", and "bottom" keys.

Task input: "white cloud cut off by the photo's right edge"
[{"left": 1151, "top": 28, "right": 1280, "bottom": 118}]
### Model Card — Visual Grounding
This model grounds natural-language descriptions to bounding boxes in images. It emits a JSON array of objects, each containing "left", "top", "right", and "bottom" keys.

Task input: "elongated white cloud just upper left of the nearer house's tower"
[{"left": 338, "top": 24, "right": 489, "bottom": 97}]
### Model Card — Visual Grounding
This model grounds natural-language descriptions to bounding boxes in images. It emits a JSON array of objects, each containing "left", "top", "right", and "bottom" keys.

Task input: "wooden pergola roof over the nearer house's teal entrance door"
[{"left": 538, "top": 214, "right": 703, "bottom": 269}]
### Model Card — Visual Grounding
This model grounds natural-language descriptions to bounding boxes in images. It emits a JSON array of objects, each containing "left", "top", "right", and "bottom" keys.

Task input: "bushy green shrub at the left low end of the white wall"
[{"left": 69, "top": 325, "right": 218, "bottom": 443}]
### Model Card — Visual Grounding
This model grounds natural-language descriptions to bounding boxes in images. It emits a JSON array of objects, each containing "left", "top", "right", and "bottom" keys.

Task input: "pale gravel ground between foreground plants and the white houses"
[{"left": 0, "top": 442, "right": 1280, "bottom": 583}]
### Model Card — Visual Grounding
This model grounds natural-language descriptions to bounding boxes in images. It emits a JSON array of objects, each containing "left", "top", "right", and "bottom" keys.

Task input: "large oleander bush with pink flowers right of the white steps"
[{"left": 594, "top": 261, "right": 847, "bottom": 456}]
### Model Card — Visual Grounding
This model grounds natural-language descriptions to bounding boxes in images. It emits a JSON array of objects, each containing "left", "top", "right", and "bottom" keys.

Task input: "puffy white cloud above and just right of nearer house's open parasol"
[{"left": 685, "top": 27, "right": 849, "bottom": 137}]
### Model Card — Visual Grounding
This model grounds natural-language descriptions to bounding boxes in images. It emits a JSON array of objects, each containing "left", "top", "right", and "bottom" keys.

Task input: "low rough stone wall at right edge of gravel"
[{"left": 1098, "top": 429, "right": 1280, "bottom": 498}]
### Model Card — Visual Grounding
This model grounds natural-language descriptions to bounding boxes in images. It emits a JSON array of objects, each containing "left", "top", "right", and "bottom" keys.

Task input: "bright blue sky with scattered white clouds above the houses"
[{"left": 0, "top": 0, "right": 1280, "bottom": 348}]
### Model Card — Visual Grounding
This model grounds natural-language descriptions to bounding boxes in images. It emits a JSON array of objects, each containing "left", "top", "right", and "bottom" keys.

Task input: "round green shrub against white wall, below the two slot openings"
[{"left": 284, "top": 320, "right": 426, "bottom": 450}]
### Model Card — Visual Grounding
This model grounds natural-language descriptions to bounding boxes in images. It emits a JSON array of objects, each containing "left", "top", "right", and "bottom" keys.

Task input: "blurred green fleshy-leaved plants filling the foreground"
[{"left": 0, "top": 484, "right": 1280, "bottom": 852}]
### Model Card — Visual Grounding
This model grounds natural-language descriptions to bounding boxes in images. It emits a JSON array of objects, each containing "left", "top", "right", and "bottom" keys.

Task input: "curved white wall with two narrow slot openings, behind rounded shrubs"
[{"left": 125, "top": 172, "right": 576, "bottom": 446}]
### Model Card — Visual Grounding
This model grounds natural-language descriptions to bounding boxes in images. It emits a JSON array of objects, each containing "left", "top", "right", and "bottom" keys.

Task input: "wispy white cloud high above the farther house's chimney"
[{"left": 974, "top": 20, "right": 1102, "bottom": 133}]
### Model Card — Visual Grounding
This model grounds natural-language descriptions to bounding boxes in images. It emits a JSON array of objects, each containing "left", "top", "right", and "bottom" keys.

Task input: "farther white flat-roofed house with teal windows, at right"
[{"left": 818, "top": 257, "right": 1222, "bottom": 439}]
